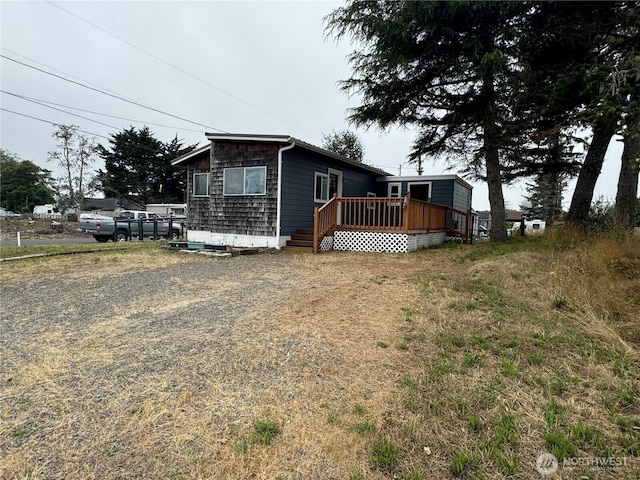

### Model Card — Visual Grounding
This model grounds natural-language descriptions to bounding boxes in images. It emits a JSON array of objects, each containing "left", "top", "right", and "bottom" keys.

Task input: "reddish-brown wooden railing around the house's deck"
[{"left": 313, "top": 195, "right": 470, "bottom": 253}]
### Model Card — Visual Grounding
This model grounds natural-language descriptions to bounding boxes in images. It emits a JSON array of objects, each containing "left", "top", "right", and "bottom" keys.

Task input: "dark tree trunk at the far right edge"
[{"left": 614, "top": 124, "right": 640, "bottom": 230}]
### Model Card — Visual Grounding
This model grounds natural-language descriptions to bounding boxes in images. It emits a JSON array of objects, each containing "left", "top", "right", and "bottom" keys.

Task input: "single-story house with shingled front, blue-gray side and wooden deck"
[{"left": 172, "top": 133, "right": 472, "bottom": 252}]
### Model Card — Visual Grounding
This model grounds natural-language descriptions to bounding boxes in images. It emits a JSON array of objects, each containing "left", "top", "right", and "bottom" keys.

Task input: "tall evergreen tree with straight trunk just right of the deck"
[{"left": 327, "top": 1, "right": 529, "bottom": 240}]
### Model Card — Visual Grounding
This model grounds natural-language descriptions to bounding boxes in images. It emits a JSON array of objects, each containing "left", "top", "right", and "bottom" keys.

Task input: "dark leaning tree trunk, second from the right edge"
[{"left": 567, "top": 120, "right": 616, "bottom": 225}]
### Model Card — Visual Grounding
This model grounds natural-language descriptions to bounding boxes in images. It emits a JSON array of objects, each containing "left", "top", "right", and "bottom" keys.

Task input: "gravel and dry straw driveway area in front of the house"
[{"left": 0, "top": 252, "right": 437, "bottom": 479}]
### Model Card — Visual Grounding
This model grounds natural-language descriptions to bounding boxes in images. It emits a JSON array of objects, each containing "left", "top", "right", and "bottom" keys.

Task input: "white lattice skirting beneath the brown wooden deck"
[{"left": 332, "top": 231, "right": 447, "bottom": 253}]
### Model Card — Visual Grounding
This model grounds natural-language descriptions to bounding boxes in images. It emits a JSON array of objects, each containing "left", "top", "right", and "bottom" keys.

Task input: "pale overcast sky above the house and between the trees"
[{"left": 0, "top": 0, "right": 622, "bottom": 210}]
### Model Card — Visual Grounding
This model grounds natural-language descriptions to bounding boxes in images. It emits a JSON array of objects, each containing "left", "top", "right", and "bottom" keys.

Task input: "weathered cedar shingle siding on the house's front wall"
[{"left": 188, "top": 141, "right": 283, "bottom": 236}]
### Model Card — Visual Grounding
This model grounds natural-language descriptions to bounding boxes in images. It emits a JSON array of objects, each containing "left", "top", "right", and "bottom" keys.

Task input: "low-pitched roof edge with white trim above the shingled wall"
[{"left": 171, "top": 133, "right": 389, "bottom": 176}]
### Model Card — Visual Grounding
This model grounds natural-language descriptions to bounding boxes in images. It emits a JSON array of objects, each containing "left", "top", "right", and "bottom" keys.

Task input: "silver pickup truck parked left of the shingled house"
[{"left": 78, "top": 210, "right": 183, "bottom": 243}]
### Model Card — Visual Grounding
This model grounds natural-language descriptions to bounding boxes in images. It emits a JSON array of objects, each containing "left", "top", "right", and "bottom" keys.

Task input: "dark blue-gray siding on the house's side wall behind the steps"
[{"left": 280, "top": 147, "right": 378, "bottom": 235}]
